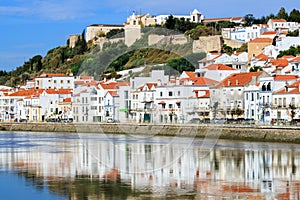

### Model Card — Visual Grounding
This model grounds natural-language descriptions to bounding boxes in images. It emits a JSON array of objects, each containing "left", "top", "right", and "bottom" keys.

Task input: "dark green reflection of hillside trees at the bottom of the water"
[{"left": 18, "top": 171, "right": 132, "bottom": 199}]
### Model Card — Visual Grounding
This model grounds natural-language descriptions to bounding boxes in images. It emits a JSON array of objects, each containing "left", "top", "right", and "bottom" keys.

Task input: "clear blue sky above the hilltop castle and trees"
[{"left": 0, "top": 0, "right": 299, "bottom": 71}]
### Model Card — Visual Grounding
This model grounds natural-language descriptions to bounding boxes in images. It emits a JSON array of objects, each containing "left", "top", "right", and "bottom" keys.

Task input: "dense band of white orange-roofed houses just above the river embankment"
[{"left": 0, "top": 47, "right": 300, "bottom": 124}]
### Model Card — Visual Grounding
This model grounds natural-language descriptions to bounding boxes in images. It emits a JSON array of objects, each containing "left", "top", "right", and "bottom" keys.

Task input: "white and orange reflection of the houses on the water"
[{"left": 0, "top": 133, "right": 300, "bottom": 199}]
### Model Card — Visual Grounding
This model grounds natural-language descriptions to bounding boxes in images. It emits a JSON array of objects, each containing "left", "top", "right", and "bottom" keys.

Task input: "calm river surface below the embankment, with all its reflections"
[{"left": 0, "top": 132, "right": 300, "bottom": 199}]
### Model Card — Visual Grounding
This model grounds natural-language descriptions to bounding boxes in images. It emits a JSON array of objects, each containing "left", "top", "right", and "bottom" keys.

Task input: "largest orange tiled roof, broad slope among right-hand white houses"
[{"left": 215, "top": 71, "right": 262, "bottom": 88}]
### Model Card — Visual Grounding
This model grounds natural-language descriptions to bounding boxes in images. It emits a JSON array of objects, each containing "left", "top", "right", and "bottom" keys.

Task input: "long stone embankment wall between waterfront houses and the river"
[{"left": 0, "top": 123, "right": 300, "bottom": 144}]
